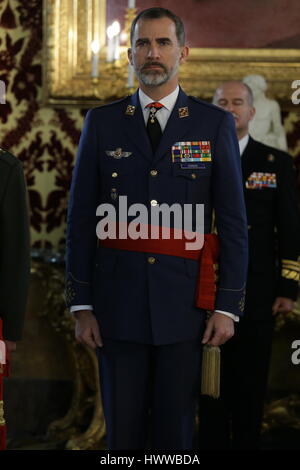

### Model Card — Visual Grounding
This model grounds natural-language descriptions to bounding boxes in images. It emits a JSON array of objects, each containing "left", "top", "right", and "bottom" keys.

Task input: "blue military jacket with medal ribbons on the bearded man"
[{"left": 66, "top": 89, "right": 248, "bottom": 344}]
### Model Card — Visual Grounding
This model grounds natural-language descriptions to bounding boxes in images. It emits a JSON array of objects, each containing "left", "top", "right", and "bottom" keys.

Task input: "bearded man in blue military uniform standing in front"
[{"left": 66, "top": 8, "right": 248, "bottom": 449}]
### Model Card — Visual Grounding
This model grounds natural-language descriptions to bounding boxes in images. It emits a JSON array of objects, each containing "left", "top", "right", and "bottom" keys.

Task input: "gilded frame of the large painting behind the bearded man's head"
[{"left": 43, "top": 0, "right": 300, "bottom": 109}]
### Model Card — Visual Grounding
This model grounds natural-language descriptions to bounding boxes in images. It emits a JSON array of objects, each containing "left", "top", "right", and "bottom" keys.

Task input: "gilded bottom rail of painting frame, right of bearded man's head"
[{"left": 181, "top": 48, "right": 300, "bottom": 108}]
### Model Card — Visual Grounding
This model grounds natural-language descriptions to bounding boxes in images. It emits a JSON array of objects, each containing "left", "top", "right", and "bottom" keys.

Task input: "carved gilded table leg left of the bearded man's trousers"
[{"left": 33, "top": 263, "right": 106, "bottom": 450}]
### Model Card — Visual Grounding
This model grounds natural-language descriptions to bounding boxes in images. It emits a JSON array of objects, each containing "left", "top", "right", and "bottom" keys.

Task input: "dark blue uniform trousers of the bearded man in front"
[{"left": 98, "top": 335, "right": 202, "bottom": 450}]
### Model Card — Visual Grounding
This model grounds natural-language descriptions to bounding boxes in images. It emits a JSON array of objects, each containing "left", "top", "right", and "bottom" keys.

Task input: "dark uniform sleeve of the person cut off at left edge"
[{"left": 0, "top": 148, "right": 30, "bottom": 343}]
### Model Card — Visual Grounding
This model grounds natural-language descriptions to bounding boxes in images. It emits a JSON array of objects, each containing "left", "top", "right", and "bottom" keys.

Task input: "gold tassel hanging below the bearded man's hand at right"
[{"left": 201, "top": 345, "right": 221, "bottom": 398}]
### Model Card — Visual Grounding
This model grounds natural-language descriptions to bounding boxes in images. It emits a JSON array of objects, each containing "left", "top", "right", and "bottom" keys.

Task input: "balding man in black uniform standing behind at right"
[{"left": 199, "top": 81, "right": 300, "bottom": 450}]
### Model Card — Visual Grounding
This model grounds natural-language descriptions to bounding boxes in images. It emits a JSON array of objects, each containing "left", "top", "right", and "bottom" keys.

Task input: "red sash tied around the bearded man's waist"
[{"left": 98, "top": 229, "right": 219, "bottom": 310}]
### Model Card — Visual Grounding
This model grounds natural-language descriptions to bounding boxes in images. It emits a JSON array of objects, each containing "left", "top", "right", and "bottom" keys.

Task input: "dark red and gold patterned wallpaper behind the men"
[{"left": 0, "top": 0, "right": 300, "bottom": 251}]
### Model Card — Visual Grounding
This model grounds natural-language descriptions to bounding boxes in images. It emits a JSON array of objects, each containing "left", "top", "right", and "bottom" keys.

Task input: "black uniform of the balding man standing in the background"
[{"left": 237, "top": 136, "right": 300, "bottom": 449}]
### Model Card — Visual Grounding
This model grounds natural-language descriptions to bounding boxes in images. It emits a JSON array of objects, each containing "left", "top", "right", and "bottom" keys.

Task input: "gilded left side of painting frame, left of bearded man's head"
[{"left": 43, "top": 0, "right": 111, "bottom": 104}]
